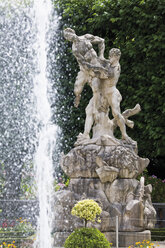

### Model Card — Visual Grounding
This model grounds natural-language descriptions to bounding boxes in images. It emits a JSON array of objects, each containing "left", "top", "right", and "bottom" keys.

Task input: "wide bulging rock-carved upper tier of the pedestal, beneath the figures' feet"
[{"left": 61, "top": 144, "right": 149, "bottom": 180}]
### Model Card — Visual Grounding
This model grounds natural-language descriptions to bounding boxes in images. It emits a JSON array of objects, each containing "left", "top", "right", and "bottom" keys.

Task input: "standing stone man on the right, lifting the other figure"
[{"left": 84, "top": 48, "right": 135, "bottom": 142}]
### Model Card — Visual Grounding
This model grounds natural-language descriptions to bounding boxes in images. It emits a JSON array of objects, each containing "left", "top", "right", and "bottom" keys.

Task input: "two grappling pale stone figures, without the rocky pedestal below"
[{"left": 64, "top": 28, "right": 140, "bottom": 145}]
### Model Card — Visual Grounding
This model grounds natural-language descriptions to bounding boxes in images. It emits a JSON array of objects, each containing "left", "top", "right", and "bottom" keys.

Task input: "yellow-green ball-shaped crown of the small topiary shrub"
[{"left": 71, "top": 199, "right": 102, "bottom": 227}]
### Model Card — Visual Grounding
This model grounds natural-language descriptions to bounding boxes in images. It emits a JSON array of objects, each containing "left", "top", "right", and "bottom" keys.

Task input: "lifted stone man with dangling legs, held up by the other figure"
[{"left": 64, "top": 28, "right": 105, "bottom": 107}]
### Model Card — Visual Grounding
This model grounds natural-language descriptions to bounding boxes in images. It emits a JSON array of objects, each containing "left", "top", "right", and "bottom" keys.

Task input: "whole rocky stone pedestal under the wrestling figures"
[{"left": 53, "top": 144, "right": 156, "bottom": 247}]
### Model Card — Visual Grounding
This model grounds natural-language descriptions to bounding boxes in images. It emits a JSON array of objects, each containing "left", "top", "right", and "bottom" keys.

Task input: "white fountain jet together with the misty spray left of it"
[{"left": 0, "top": 0, "right": 57, "bottom": 248}]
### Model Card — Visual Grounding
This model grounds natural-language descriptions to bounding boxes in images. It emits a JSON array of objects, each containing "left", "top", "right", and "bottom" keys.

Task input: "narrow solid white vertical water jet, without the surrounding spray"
[{"left": 34, "top": 0, "right": 56, "bottom": 248}]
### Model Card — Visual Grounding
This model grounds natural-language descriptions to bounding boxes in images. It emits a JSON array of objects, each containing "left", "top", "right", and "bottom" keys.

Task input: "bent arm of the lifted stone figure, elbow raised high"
[{"left": 84, "top": 34, "right": 105, "bottom": 59}]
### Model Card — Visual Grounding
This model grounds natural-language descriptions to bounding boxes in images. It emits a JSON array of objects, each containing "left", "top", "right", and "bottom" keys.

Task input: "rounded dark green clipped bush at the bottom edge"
[{"left": 64, "top": 228, "right": 110, "bottom": 248}]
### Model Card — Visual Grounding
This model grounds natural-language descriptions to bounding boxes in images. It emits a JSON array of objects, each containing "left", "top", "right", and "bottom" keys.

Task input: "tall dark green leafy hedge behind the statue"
[{"left": 52, "top": 0, "right": 165, "bottom": 174}]
